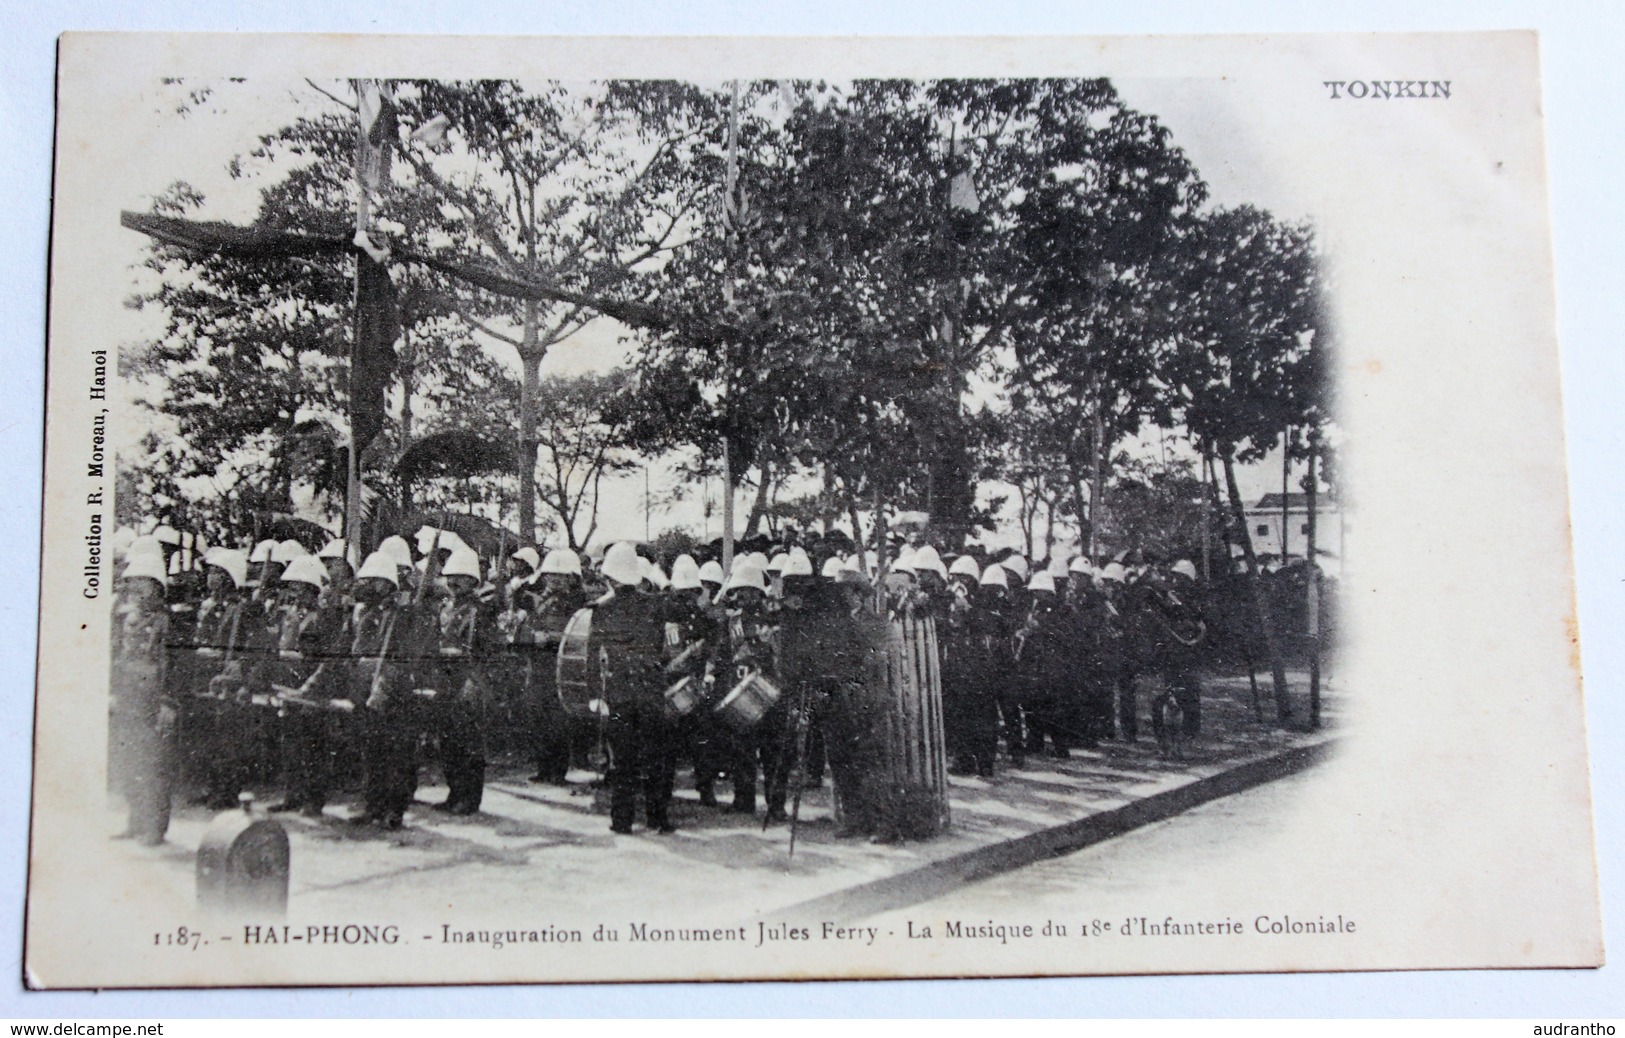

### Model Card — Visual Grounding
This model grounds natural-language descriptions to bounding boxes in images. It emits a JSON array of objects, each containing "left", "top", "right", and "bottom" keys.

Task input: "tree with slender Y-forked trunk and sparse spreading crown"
[{"left": 391, "top": 80, "right": 702, "bottom": 538}]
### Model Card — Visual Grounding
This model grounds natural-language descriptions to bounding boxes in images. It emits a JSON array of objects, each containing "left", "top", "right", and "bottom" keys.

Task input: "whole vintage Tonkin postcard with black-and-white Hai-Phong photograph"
[{"left": 24, "top": 32, "right": 1604, "bottom": 988}]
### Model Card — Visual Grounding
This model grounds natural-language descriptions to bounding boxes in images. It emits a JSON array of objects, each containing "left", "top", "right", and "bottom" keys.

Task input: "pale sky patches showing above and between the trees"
[{"left": 109, "top": 78, "right": 1316, "bottom": 546}]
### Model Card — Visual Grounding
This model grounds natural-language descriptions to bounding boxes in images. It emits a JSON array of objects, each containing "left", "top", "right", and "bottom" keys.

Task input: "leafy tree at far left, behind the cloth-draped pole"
[{"left": 124, "top": 101, "right": 507, "bottom": 549}]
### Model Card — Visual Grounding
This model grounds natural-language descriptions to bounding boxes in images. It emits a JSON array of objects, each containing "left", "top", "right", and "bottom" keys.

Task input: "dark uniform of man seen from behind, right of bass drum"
[{"left": 593, "top": 585, "right": 676, "bottom": 833}]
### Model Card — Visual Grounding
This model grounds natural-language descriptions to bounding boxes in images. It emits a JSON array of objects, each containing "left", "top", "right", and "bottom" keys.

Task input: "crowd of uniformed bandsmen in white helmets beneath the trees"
[{"left": 109, "top": 526, "right": 1211, "bottom": 843}]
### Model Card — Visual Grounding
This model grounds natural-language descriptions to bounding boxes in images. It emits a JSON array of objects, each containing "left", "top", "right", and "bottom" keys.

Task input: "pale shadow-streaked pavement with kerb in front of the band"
[{"left": 107, "top": 674, "right": 1337, "bottom": 921}]
